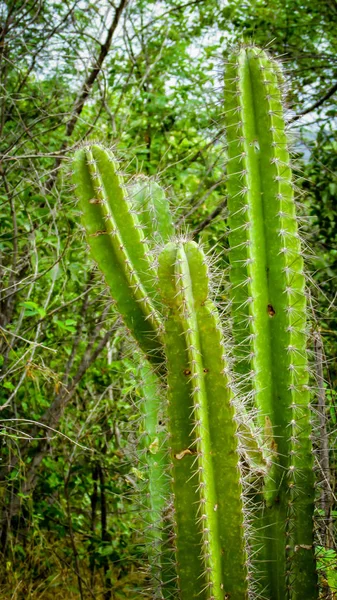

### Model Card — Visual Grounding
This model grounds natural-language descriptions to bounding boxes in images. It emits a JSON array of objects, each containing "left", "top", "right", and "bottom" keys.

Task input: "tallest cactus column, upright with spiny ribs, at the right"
[{"left": 225, "top": 47, "right": 317, "bottom": 600}]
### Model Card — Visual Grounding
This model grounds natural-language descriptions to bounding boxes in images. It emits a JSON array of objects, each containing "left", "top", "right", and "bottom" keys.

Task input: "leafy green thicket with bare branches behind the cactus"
[{"left": 0, "top": 0, "right": 337, "bottom": 600}]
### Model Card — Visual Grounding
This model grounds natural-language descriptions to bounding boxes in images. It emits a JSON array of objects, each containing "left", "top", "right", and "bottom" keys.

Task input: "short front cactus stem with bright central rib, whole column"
[{"left": 158, "top": 242, "right": 248, "bottom": 600}]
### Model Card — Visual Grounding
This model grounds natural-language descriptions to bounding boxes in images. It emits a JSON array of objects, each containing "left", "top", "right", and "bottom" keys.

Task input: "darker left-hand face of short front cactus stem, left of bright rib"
[{"left": 158, "top": 243, "right": 207, "bottom": 600}]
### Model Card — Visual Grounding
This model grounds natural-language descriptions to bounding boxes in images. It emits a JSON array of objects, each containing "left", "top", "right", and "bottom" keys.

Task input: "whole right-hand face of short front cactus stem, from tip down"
[{"left": 184, "top": 242, "right": 247, "bottom": 599}]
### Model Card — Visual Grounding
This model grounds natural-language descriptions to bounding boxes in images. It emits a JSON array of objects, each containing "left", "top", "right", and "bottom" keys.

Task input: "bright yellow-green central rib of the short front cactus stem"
[{"left": 175, "top": 243, "right": 222, "bottom": 599}]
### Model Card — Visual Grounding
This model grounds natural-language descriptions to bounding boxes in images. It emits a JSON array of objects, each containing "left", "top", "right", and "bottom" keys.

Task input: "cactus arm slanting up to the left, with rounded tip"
[{"left": 73, "top": 145, "right": 163, "bottom": 364}]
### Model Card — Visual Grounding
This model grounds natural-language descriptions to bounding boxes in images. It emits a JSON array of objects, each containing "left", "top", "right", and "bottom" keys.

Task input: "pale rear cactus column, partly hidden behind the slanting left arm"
[{"left": 128, "top": 186, "right": 176, "bottom": 600}]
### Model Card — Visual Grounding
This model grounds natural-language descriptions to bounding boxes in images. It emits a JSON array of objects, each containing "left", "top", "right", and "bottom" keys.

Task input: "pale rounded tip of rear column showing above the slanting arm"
[{"left": 128, "top": 175, "right": 174, "bottom": 244}]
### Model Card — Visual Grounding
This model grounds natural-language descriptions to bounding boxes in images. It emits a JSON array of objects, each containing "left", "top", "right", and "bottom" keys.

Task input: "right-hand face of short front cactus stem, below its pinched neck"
[{"left": 198, "top": 302, "right": 247, "bottom": 600}]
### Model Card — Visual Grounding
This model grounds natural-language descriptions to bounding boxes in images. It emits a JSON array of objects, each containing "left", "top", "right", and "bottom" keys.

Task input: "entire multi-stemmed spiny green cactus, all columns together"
[{"left": 70, "top": 47, "right": 318, "bottom": 600}]
